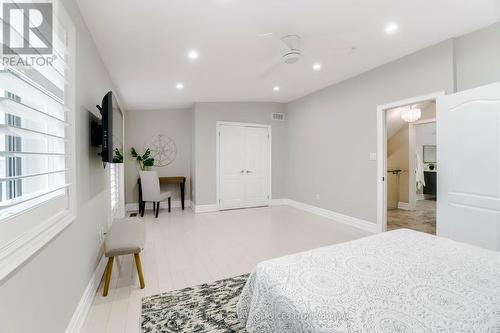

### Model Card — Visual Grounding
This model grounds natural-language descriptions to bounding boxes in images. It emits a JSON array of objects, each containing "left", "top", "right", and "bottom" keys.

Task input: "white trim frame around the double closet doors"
[{"left": 215, "top": 121, "right": 273, "bottom": 211}]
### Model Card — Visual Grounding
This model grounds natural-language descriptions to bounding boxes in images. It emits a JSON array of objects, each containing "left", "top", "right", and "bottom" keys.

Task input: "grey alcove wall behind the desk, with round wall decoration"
[{"left": 125, "top": 109, "right": 192, "bottom": 203}]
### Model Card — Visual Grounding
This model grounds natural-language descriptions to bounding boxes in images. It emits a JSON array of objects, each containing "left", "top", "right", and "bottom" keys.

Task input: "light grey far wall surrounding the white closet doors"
[{"left": 193, "top": 102, "right": 286, "bottom": 205}]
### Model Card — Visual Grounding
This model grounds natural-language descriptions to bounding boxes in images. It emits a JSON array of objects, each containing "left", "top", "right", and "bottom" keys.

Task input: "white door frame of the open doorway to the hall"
[{"left": 377, "top": 90, "right": 446, "bottom": 233}]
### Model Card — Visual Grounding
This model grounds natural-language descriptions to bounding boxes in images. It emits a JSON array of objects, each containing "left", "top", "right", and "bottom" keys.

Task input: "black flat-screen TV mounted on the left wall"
[{"left": 91, "top": 91, "right": 123, "bottom": 163}]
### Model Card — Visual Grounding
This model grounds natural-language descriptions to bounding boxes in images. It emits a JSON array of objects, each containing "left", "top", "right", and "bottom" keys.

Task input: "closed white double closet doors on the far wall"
[{"left": 217, "top": 123, "right": 271, "bottom": 209}]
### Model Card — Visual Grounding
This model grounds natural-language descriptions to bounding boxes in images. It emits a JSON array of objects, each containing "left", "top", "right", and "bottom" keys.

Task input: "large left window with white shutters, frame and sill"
[{"left": 0, "top": 0, "right": 76, "bottom": 281}]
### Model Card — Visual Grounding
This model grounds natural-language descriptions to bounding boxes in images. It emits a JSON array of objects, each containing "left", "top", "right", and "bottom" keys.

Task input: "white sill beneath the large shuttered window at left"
[{"left": 0, "top": 211, "right": 76, "bottom": 283}]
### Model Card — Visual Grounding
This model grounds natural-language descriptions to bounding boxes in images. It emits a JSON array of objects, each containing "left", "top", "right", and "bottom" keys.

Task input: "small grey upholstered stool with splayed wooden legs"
[{"left": 102, "top": 218, "right": 146, "bottom": 296}]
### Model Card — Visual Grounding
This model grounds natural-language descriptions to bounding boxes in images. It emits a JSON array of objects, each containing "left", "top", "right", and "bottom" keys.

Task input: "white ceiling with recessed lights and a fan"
[{"left": 78, "top": 0, "right": 500, "bottom": 110}]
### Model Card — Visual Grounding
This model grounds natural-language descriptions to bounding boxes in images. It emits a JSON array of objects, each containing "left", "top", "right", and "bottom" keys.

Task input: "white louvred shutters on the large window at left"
[{"left": 0, "top": 2, "right": 72, "bottom": 222}]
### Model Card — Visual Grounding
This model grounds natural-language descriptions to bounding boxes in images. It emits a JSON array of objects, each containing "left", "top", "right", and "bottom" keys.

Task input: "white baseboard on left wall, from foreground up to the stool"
[{"left": 66, "top": 256, "right": 106, "bottom": 333}]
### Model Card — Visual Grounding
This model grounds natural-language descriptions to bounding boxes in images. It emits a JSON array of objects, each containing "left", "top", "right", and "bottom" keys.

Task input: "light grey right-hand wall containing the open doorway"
[{"left": 286, "top": 23, "right": 500, "bottom": 223}]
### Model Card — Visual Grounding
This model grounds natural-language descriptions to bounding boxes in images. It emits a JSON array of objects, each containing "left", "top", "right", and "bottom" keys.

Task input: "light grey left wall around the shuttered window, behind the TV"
[{"left": 0, "top": 0, "right": 118, "bottom": 333}]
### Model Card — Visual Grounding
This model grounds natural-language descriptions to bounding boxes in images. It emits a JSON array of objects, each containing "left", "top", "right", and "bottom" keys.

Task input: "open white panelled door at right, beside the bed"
[{"left": 437, "top": 83, "right": 500, "bottom": 251}]
